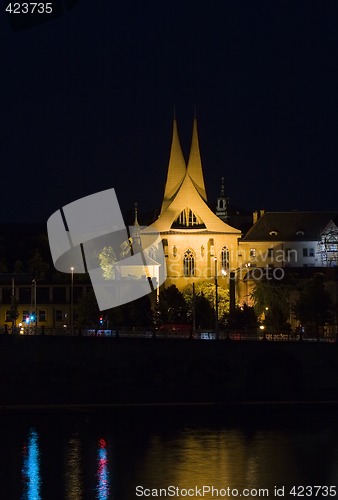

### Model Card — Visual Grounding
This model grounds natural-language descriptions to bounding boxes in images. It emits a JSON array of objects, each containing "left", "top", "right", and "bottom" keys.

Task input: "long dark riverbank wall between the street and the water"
[{"left": 0, "top": 335, "right": 338, "bottom": 407}]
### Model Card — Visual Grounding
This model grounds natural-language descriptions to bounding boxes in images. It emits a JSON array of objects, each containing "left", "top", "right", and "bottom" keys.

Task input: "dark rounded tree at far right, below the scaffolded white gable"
[{"left": 293, "top": 276, "right": 332, "bottom": 335}]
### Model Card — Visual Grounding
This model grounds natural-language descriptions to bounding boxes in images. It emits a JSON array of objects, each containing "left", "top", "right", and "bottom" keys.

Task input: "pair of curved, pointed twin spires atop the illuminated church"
[{"left": 161, "top": 116, "right": 207, "bottom": 213}]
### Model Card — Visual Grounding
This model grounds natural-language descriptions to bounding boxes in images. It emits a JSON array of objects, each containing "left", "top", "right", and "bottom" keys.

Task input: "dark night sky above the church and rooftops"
[{"left": 0, "top": 0, "right": 338, "bottom": 222}]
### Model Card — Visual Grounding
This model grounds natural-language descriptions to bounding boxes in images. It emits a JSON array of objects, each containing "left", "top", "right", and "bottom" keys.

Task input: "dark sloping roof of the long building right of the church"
[{"left": 242, "top": 212, "right": 338, "bottom": 242}]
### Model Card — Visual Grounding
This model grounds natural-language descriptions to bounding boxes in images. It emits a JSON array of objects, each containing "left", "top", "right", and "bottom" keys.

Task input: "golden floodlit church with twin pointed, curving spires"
[{"left": 147, "top": 118, "right": 241, "bottom": 291}]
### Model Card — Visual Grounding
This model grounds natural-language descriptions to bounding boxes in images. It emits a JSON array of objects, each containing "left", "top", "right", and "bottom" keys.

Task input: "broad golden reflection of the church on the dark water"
[{"left": 132, "top": 428, "right": 299, "bottom": 488}]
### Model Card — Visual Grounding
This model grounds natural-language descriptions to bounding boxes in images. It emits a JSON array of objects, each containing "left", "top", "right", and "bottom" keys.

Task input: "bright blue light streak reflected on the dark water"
[{"left": 22, "top": 429, "right": 41, "bottom": 500}]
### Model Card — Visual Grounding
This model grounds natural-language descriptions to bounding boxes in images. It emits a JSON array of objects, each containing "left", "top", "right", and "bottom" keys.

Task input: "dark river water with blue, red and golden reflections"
[{"left": 0, "top": 405, "right": 338, "bottom": 500}]
